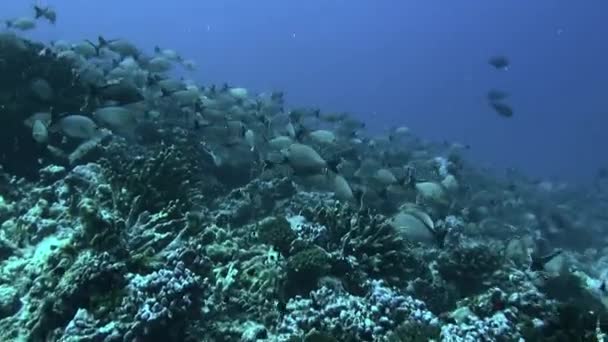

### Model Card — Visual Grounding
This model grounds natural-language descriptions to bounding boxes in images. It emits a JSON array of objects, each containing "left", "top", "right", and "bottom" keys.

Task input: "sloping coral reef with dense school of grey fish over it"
[{"left": 0, "top": 32, "right": 608, "bottom": 342}]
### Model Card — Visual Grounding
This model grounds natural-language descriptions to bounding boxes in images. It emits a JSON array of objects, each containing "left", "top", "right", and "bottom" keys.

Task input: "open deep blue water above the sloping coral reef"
[{"left": 0, "top": 0, "right": 608, "bottom": 182}]
